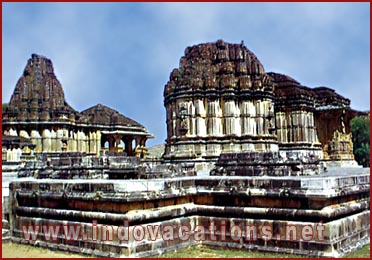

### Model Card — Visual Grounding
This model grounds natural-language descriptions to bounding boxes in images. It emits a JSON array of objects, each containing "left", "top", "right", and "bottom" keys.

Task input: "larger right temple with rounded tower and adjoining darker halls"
[{"left": 164, "top": 40, "right": 361, "bottom": 167}]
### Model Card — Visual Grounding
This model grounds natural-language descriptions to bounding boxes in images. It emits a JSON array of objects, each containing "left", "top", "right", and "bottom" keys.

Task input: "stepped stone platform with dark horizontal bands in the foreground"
[{"left": 9, "top": 168, "right": 370, "bottom": 257}]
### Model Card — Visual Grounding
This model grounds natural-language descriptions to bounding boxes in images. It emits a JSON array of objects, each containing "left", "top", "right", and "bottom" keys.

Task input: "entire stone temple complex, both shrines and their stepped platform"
[{"left": 2, "top": 40, "right": 370, "bottom": 257}]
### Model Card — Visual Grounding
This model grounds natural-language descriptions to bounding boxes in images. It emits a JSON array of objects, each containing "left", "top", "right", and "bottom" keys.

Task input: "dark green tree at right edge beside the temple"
[{"left": 350, "top": 114, "right": 370, "bottom": 167}]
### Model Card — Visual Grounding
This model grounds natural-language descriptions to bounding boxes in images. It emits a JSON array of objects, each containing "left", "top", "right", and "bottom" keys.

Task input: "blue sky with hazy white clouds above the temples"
[{"left": 2, "top": 3, "right": 370, "bottom": 146}]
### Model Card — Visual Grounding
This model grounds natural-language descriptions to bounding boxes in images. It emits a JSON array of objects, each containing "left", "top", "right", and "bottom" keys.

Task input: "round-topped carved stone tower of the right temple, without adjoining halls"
[{"left": 164, "top": 40, "right": 278, "bottom": 160}]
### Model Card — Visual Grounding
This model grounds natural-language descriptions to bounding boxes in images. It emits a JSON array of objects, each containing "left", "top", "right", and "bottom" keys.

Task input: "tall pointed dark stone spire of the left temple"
[{"left": 3, "top": 54, "right": 78, "bottom": 122}]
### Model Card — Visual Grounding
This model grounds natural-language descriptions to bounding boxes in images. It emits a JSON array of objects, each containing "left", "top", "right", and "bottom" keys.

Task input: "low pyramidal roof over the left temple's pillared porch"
[{"left": 81, "top": 104, "right": 144, "bottom": 128}]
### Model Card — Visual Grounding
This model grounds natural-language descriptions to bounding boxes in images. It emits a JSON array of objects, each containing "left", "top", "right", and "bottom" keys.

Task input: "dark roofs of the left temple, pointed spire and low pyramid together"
[{"left": 2, "top": 54, "right": 152, "bottom": 137}]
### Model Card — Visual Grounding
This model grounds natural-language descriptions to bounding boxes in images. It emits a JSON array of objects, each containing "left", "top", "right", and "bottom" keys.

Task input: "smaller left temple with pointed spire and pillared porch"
[{"left": 2, "top": 54, "right": 153, "bottom": 158}]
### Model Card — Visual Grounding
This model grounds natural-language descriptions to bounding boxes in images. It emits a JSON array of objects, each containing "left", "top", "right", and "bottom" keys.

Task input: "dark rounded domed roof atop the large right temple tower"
[{"left": 164, "top": 40, "right": 265, "bottom": 96}]
